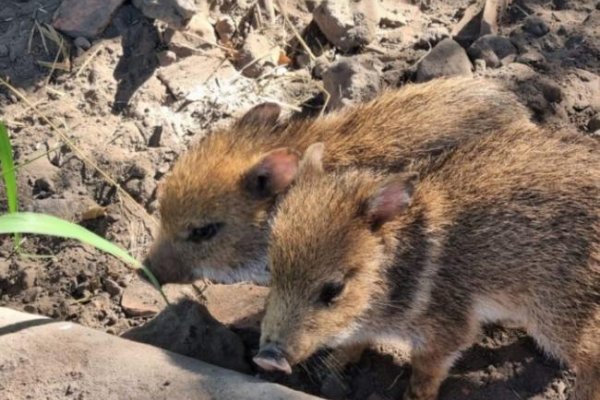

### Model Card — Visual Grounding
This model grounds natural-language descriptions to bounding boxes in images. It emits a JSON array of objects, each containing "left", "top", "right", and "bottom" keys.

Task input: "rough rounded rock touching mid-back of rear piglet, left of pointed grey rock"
[{"left": 323, "top": 57, "right": 381, "bottom": 110}]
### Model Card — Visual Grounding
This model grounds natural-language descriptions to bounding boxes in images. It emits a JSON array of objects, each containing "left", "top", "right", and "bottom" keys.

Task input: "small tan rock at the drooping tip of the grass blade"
[{"left": 121, "top": 279, "right": 165, "bottom": 317}]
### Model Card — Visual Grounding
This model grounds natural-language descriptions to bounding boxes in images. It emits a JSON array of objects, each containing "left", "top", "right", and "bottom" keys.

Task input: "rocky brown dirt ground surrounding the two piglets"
[{"left": 0, "top": 0, "right": 600, "bottom": 400}]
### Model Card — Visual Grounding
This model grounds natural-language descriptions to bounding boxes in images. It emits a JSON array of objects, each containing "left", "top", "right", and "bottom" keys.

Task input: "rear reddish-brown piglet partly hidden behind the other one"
[{"left": 147, "top": 78, "right": 529, "bottom": 283}]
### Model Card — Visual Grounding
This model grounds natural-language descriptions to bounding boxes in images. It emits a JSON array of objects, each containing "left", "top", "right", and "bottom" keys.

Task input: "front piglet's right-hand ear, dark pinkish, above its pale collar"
[{"left": 367, "top": 174, "right": 417, "bottom": 230}]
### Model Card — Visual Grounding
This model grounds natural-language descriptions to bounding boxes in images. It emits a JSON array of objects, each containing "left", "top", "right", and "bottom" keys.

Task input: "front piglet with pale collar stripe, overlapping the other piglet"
[{"left": 257, "top": 124, "right": 600, "bottom": 400}]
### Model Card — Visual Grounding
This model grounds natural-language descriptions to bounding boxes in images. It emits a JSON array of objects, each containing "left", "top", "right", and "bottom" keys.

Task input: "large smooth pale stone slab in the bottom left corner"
[{"left": 0, "top": 308, "right": 324, "bottom": 400}]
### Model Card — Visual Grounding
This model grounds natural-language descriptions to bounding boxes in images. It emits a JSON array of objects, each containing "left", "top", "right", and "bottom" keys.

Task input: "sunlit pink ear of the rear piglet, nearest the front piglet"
[{"left": 243, "top": 147, "right": 300, "bottom": 198}]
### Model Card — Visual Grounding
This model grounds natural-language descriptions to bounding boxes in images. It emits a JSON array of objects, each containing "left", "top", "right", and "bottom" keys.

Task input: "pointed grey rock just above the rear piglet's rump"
[{"left": 416, "top": 39, "right": 473, "bottom": 82}]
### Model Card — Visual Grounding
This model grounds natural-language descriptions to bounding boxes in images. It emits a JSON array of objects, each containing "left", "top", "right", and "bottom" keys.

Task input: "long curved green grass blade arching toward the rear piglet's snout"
[{"left": 0, "top": 212, "right": 168, "bottom": 303}]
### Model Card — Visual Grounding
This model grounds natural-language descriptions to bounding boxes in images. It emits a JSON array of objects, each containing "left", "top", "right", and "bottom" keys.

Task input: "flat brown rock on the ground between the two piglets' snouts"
[{"left": 202, "top": 283, "right": 269, "bottom": 332}]
